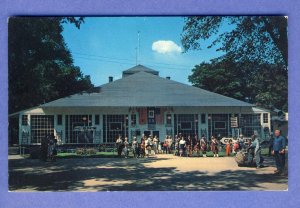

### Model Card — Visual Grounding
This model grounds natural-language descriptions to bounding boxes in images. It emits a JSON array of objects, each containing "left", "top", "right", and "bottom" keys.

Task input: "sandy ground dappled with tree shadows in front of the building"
[{"left": 9, "top": 155, "right": 287, "bottom": 191}]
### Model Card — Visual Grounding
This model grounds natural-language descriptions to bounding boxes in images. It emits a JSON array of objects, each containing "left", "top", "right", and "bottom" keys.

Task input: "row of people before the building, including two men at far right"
[{"left": 116, "top": 130, "right": 286, "bottom": 174}]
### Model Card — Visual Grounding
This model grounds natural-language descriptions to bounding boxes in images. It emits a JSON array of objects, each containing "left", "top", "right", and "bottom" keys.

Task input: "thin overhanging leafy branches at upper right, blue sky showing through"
[{"left": 182, "top": 16, "right": 288, "bottom": 69}]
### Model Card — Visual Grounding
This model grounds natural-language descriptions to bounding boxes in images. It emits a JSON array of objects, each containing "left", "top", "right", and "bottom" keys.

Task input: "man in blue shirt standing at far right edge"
[{"left": 272, "top": 130, "right": 286, "bottom": 174}]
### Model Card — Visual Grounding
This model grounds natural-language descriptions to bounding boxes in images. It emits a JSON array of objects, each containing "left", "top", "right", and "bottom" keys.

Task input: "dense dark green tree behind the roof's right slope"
[{"left": 189, "top": 60, "right": 288, "bottom": 110}]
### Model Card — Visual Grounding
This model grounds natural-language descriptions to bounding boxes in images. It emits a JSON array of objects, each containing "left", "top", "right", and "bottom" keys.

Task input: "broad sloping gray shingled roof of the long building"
[{"left": 42, "top": 66, "right": 253, "bottom": 107}]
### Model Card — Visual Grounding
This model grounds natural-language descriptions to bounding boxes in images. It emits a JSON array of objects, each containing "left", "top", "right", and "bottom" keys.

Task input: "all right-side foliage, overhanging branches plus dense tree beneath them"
[{"left": 182, "top": 16, "right": 288, "bottom": 110}]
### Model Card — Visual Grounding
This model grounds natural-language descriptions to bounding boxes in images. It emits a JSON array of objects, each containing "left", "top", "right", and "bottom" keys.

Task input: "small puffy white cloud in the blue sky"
[{"left": 152, "top": 40, "right": 182, "bottom": 54}]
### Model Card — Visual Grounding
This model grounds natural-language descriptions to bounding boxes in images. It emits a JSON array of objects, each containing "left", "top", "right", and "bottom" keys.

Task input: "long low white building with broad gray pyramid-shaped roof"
[{"left": 18, "top": 65, "right": 271, "bottom": 145}]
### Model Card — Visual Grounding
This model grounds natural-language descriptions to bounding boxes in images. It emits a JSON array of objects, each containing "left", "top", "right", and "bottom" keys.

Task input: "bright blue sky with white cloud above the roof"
[{"left": 63, "top": 17, "right": 222, "bottom": 86}]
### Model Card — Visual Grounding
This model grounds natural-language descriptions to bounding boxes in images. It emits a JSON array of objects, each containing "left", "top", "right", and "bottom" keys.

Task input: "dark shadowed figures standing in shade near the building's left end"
[{"left": 40, "top": 134, "right": 57, "bottom": 161}]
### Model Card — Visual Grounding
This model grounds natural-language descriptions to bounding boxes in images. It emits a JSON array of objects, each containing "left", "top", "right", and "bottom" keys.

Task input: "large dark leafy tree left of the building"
[{"left": 8, "top": 17, "right": 93, "bottom": 113}]
